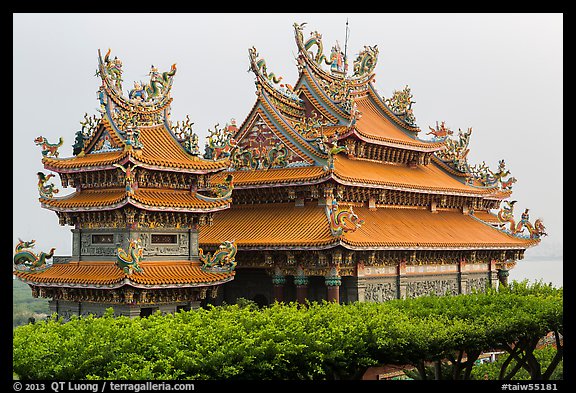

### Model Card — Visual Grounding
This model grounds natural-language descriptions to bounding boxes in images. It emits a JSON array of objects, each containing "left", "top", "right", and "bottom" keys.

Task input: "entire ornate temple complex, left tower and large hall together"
[{"left": 14, "top": 23, "right": 546, "bottom": 316}]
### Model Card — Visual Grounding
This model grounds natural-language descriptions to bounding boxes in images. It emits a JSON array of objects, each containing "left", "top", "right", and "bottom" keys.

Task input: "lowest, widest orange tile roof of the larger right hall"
[{"left": 199, "top": 203, "right": 538, "bottom": 250}]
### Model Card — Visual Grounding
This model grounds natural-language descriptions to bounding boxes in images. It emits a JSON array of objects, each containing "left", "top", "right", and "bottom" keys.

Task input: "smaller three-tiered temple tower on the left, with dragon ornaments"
[{"left": 14, "top": 51, "right": 236, "bottom": 317}]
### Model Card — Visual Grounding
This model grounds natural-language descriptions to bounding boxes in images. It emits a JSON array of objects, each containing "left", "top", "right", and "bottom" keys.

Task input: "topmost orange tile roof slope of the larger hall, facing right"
[{"left": 355, "top": 95, "right": 444, "bottom": 151}]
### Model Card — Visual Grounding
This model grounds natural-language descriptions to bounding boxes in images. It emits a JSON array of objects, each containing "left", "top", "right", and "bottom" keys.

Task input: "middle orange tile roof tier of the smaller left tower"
[{"left": 39, "top": 188, "right": 230, "bottom": 211}]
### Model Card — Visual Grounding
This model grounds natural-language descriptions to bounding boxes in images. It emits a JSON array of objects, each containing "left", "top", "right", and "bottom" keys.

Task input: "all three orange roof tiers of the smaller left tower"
[{"left": 14, "top": 50, "right": 234, "bottom": 289}]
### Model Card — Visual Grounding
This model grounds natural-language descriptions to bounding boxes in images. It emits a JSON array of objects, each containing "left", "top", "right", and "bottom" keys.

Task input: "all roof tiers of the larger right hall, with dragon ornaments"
[{"left": 200, "top": 24, "right": 540, "bottom": 249}]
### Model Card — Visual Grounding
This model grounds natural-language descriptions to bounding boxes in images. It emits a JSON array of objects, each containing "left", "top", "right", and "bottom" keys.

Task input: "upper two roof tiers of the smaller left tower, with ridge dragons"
[{"left": 40, "top": 51, "right": 230, "bottom": 217}]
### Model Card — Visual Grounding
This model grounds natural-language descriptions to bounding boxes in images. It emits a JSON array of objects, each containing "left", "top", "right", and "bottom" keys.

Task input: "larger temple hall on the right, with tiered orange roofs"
[{"left": 199, "top": 24, "right": 545, "bottom": 304}]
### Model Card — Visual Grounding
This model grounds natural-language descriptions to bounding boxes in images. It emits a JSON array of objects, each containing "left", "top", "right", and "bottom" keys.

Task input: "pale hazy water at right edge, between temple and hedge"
[{"left": 508, "top": 256, "right": 564, "bottom": 288}]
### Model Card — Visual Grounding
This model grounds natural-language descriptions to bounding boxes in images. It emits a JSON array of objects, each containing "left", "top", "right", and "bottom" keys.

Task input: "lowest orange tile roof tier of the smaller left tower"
[{"left": 13, "top": 261, "right": 235, "bottom": 288}]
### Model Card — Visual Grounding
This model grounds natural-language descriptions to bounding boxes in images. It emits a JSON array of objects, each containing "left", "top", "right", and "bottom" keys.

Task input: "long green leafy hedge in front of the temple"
[{"left": 13, "top": 283, "right": 563, "bottom": 380}]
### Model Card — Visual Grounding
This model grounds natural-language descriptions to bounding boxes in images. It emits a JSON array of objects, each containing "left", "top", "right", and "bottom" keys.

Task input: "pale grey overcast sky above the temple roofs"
[{"left": 13, "top": 13, "right": 563, "bottom": 270}]
